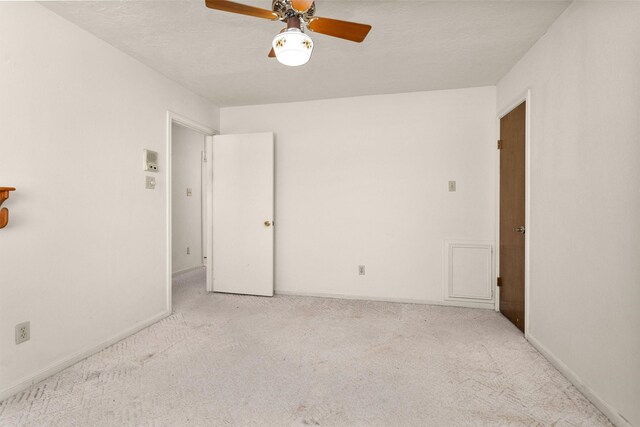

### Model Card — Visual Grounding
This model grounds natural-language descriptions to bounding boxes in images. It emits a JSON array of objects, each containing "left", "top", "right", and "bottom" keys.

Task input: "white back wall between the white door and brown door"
[{"left": 220, "top": 87, "right": 495, "bottom": 302}]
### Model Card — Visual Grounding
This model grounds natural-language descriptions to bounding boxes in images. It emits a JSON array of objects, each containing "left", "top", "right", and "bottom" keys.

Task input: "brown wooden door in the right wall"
[{"left": 499, "top": 102, "right": 526, "bottom": 332}]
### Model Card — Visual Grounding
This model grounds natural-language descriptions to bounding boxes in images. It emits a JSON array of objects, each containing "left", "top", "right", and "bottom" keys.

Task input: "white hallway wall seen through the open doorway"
[{"left": 171, "top": 124, "right": 204, "bottom": 273}]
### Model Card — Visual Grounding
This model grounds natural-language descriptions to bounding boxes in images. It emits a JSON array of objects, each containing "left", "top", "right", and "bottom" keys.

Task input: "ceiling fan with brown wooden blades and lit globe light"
[{"left": 205, "top": 0, "right": 371, "bottom": 66}]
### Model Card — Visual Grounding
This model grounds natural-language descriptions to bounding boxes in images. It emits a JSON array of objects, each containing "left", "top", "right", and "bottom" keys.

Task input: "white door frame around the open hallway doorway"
[{"left": 165, "top": 110, "right": 218, "bottom": 313}]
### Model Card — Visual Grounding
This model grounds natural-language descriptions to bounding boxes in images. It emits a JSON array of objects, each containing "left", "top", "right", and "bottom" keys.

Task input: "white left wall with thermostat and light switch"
[{"left": 0, "top": 2, "right": 218, "bottom": 398}]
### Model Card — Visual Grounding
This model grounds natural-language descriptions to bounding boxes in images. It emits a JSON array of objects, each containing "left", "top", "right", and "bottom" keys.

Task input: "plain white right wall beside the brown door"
[{"left": 497, "top": 2, "right": 640, "bottom": 426}]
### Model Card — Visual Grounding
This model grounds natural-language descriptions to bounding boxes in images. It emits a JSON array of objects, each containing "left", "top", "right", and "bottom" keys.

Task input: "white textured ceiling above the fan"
[{"left": 43, "top": 0, "right": 570, "bottom": 107}]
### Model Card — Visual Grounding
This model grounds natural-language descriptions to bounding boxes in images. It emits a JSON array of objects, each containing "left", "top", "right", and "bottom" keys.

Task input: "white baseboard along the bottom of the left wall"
[{"left": 0, "top": 311, "right": 171, "bottom": 401}]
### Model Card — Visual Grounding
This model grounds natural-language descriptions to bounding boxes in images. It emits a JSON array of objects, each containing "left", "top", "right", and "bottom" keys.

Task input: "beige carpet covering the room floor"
[{"left": 0, "top": 271, "right": 610, "bottom": 427}]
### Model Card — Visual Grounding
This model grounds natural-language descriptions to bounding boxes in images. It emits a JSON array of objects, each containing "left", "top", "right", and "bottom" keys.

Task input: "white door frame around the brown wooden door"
[{"left": 494, "top": 89, "right": 531, "bottom": 338}]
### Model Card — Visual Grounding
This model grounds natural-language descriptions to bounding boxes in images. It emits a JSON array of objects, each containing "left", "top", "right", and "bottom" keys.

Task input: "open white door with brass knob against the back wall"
[{"left": 208, "top": 133, "right": 273, "bottom": 296}]
